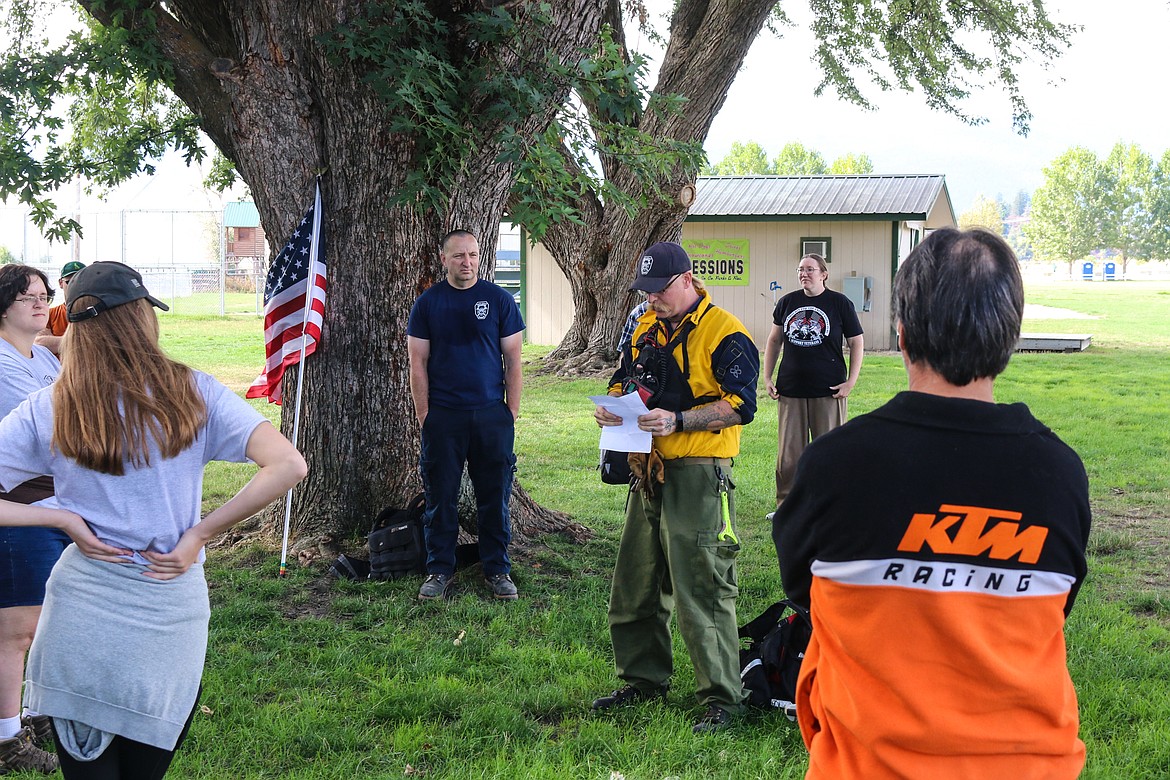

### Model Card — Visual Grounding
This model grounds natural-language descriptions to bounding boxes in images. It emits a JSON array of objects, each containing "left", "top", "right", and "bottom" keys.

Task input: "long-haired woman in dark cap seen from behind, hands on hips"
[{"left": 0, "top": 262, "right": 305, "bottom": 780}]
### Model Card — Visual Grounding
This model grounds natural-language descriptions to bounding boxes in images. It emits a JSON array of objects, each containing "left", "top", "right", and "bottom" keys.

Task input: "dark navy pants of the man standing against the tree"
[{"left": 419, "top": 401, "right": 516, "bottom": 577}]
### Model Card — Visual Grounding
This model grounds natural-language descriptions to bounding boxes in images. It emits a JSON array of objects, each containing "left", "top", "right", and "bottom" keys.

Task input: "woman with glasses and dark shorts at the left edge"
[{"left": 0, "top": 264, "right": 69, "bottom": 774}]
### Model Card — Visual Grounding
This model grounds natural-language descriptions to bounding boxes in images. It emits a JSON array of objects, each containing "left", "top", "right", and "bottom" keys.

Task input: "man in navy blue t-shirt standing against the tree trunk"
[{"left": 406, "top": 230, "right": 524, "bottom": 600}]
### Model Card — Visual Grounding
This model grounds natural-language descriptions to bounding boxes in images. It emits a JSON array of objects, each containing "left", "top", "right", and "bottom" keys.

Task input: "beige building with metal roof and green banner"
[{"left": 521, "top": 174, "right": 956, "bottom": 350}]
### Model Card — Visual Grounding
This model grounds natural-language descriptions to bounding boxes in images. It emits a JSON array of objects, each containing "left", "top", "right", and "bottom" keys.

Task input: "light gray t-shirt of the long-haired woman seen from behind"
[{"left": 0, "top": 371, "right": 264, "bottom": 564}]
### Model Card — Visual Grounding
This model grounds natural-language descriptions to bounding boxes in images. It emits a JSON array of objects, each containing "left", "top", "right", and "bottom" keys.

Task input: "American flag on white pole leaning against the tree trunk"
[{"left": 246, "top": 184, "right": 325, "bottom": 403}]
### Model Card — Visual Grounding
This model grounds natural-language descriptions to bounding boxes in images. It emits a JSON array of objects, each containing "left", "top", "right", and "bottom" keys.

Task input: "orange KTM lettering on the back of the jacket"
[{"left": 897, "top": 504, "right": 1048, "bottom": 564}]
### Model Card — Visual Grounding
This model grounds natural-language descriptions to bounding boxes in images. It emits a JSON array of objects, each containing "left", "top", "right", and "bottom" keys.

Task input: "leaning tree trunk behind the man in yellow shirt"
[{"left": 543, "top": 0, "right": 776, "bottom": 374}]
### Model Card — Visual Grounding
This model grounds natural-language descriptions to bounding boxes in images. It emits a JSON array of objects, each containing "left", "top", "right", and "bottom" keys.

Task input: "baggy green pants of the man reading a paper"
[{"left": 610, "top": 458, "right": 743, "bottom": 712}]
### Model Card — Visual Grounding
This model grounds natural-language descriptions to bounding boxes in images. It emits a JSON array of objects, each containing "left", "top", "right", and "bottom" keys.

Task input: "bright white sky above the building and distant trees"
[{"left": 650, "top": 0, "right": 1170, "bottom": 214}]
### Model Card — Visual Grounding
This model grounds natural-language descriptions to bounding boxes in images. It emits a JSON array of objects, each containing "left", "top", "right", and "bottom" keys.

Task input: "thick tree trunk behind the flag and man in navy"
[{"left": 83, "top": 0, "right": 601, "bottom": 548}]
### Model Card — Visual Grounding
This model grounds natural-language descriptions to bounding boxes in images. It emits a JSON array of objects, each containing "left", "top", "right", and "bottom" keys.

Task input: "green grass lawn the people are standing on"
[{"left": 148, "top": 282, "right": 1170, "bottom": 780}]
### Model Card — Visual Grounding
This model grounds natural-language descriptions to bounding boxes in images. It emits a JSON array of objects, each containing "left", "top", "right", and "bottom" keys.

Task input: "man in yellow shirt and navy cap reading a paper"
[{"left": 593, "top": 243, "right": 759, "bottom": 733}]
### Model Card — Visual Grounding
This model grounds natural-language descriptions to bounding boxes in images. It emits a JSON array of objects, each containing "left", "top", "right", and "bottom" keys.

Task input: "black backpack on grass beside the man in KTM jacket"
[{"left": 739, "top": 599, "right": 812, "bottom": 720}]
